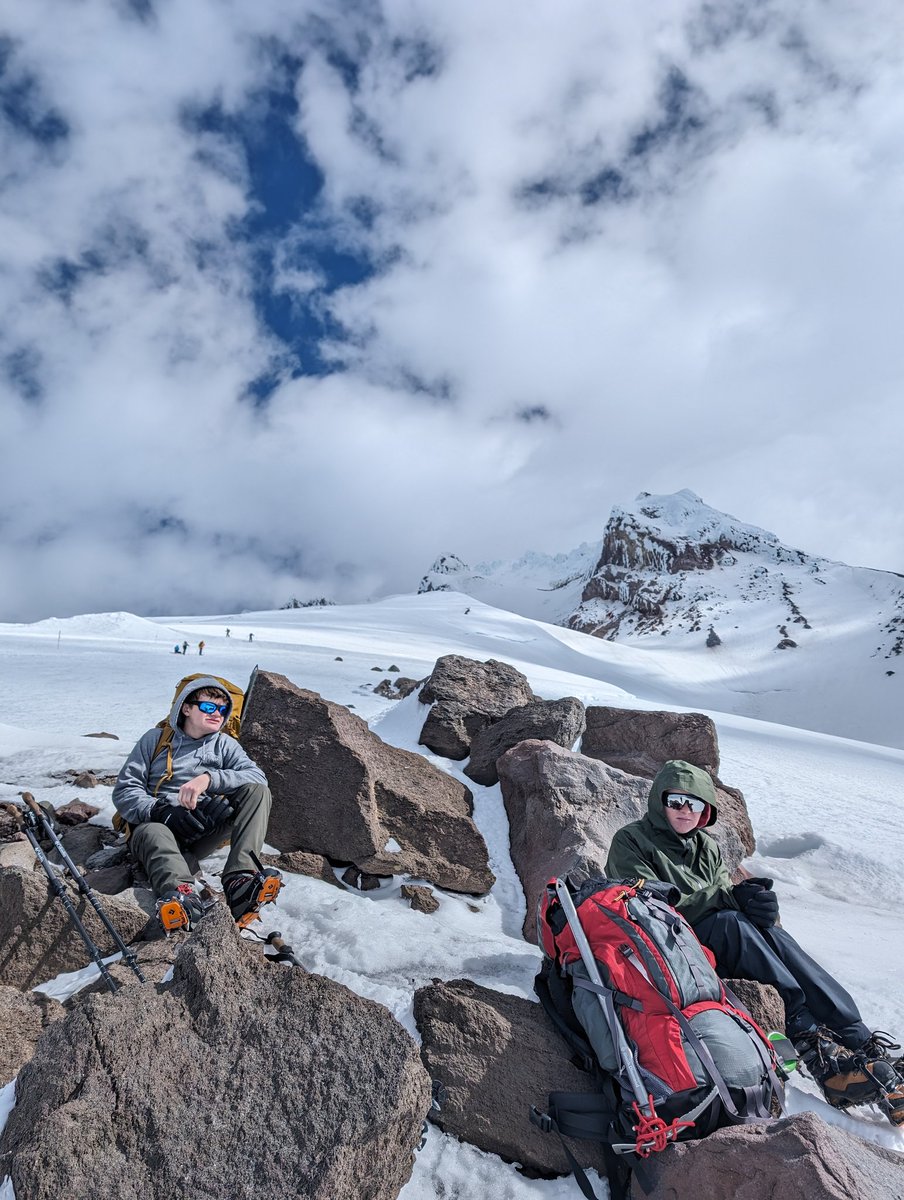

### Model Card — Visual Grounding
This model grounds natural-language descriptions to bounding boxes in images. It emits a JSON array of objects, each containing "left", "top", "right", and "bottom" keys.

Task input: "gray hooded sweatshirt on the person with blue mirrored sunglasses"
[{"left": 113, "top": 676, "right": 267, "bottom": 824}]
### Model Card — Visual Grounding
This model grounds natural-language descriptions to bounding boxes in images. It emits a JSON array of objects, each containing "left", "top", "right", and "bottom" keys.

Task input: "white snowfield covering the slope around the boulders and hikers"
[{"left": 0, "top": 593, "right": 904, "bottom": 1200}]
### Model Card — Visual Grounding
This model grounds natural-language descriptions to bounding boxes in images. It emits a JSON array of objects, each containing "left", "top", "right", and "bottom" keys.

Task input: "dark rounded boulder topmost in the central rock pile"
[{"left": 418, "top": 654, "right": 538, "bottom": 760}]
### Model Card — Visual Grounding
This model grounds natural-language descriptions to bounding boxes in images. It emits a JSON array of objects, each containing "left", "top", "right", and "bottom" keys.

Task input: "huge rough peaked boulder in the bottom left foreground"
[{"left": 0, "top": 906, "right": 430, "bottom": 1200}]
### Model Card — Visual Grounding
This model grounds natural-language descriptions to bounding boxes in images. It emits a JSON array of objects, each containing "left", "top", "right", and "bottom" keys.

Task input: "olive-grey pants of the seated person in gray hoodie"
[{"left": 128, "top": 784, "right": 271, "bottom": 898}]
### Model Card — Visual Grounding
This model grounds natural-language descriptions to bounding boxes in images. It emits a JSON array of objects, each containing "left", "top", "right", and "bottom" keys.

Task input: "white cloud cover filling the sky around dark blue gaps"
[{"left": 0, "top": 0, "right": 904, "bottom": 619}]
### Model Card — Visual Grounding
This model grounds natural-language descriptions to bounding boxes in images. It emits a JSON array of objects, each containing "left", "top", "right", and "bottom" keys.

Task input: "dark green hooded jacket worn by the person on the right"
[{"left": 606, "top": 758, "right": 737, "bottom": 925}]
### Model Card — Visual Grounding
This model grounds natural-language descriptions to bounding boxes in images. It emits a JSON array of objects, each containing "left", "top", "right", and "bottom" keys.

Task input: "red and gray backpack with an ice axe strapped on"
[{"left": 531, "top": 878, "right": 784, "bottom": 1200}]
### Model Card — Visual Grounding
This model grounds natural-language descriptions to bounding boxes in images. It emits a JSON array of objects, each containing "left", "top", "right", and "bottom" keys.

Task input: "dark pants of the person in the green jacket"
[{"left": 694, "top": 908, "right": 870, "bottom": 1049}]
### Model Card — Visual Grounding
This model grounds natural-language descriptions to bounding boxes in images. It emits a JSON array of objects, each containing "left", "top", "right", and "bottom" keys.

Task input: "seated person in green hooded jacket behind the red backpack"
[{"left": 606, "top": 760, "right": 904, "bottom": 1126}]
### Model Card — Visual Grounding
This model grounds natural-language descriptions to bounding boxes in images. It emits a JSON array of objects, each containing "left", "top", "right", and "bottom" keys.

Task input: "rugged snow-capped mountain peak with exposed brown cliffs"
[{"left": 420, "top": 491, "right": 904, "bottom": 745}]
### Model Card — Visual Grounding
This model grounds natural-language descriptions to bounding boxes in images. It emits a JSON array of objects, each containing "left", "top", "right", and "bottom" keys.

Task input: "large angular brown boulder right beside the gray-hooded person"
[{"left": 241, "top": 671, "right": 495, "bottom": 894}]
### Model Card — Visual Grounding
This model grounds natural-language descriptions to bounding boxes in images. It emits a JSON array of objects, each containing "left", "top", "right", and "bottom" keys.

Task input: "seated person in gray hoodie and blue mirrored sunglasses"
[{"left": 113, "top": 676, "right": 281, "bottom": 929}]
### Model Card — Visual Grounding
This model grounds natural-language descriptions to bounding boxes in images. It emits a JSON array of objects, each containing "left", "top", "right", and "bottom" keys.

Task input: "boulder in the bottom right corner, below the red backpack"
[{"left": 631, "top": 1112, "right": 904, "bottom": 1200}]
